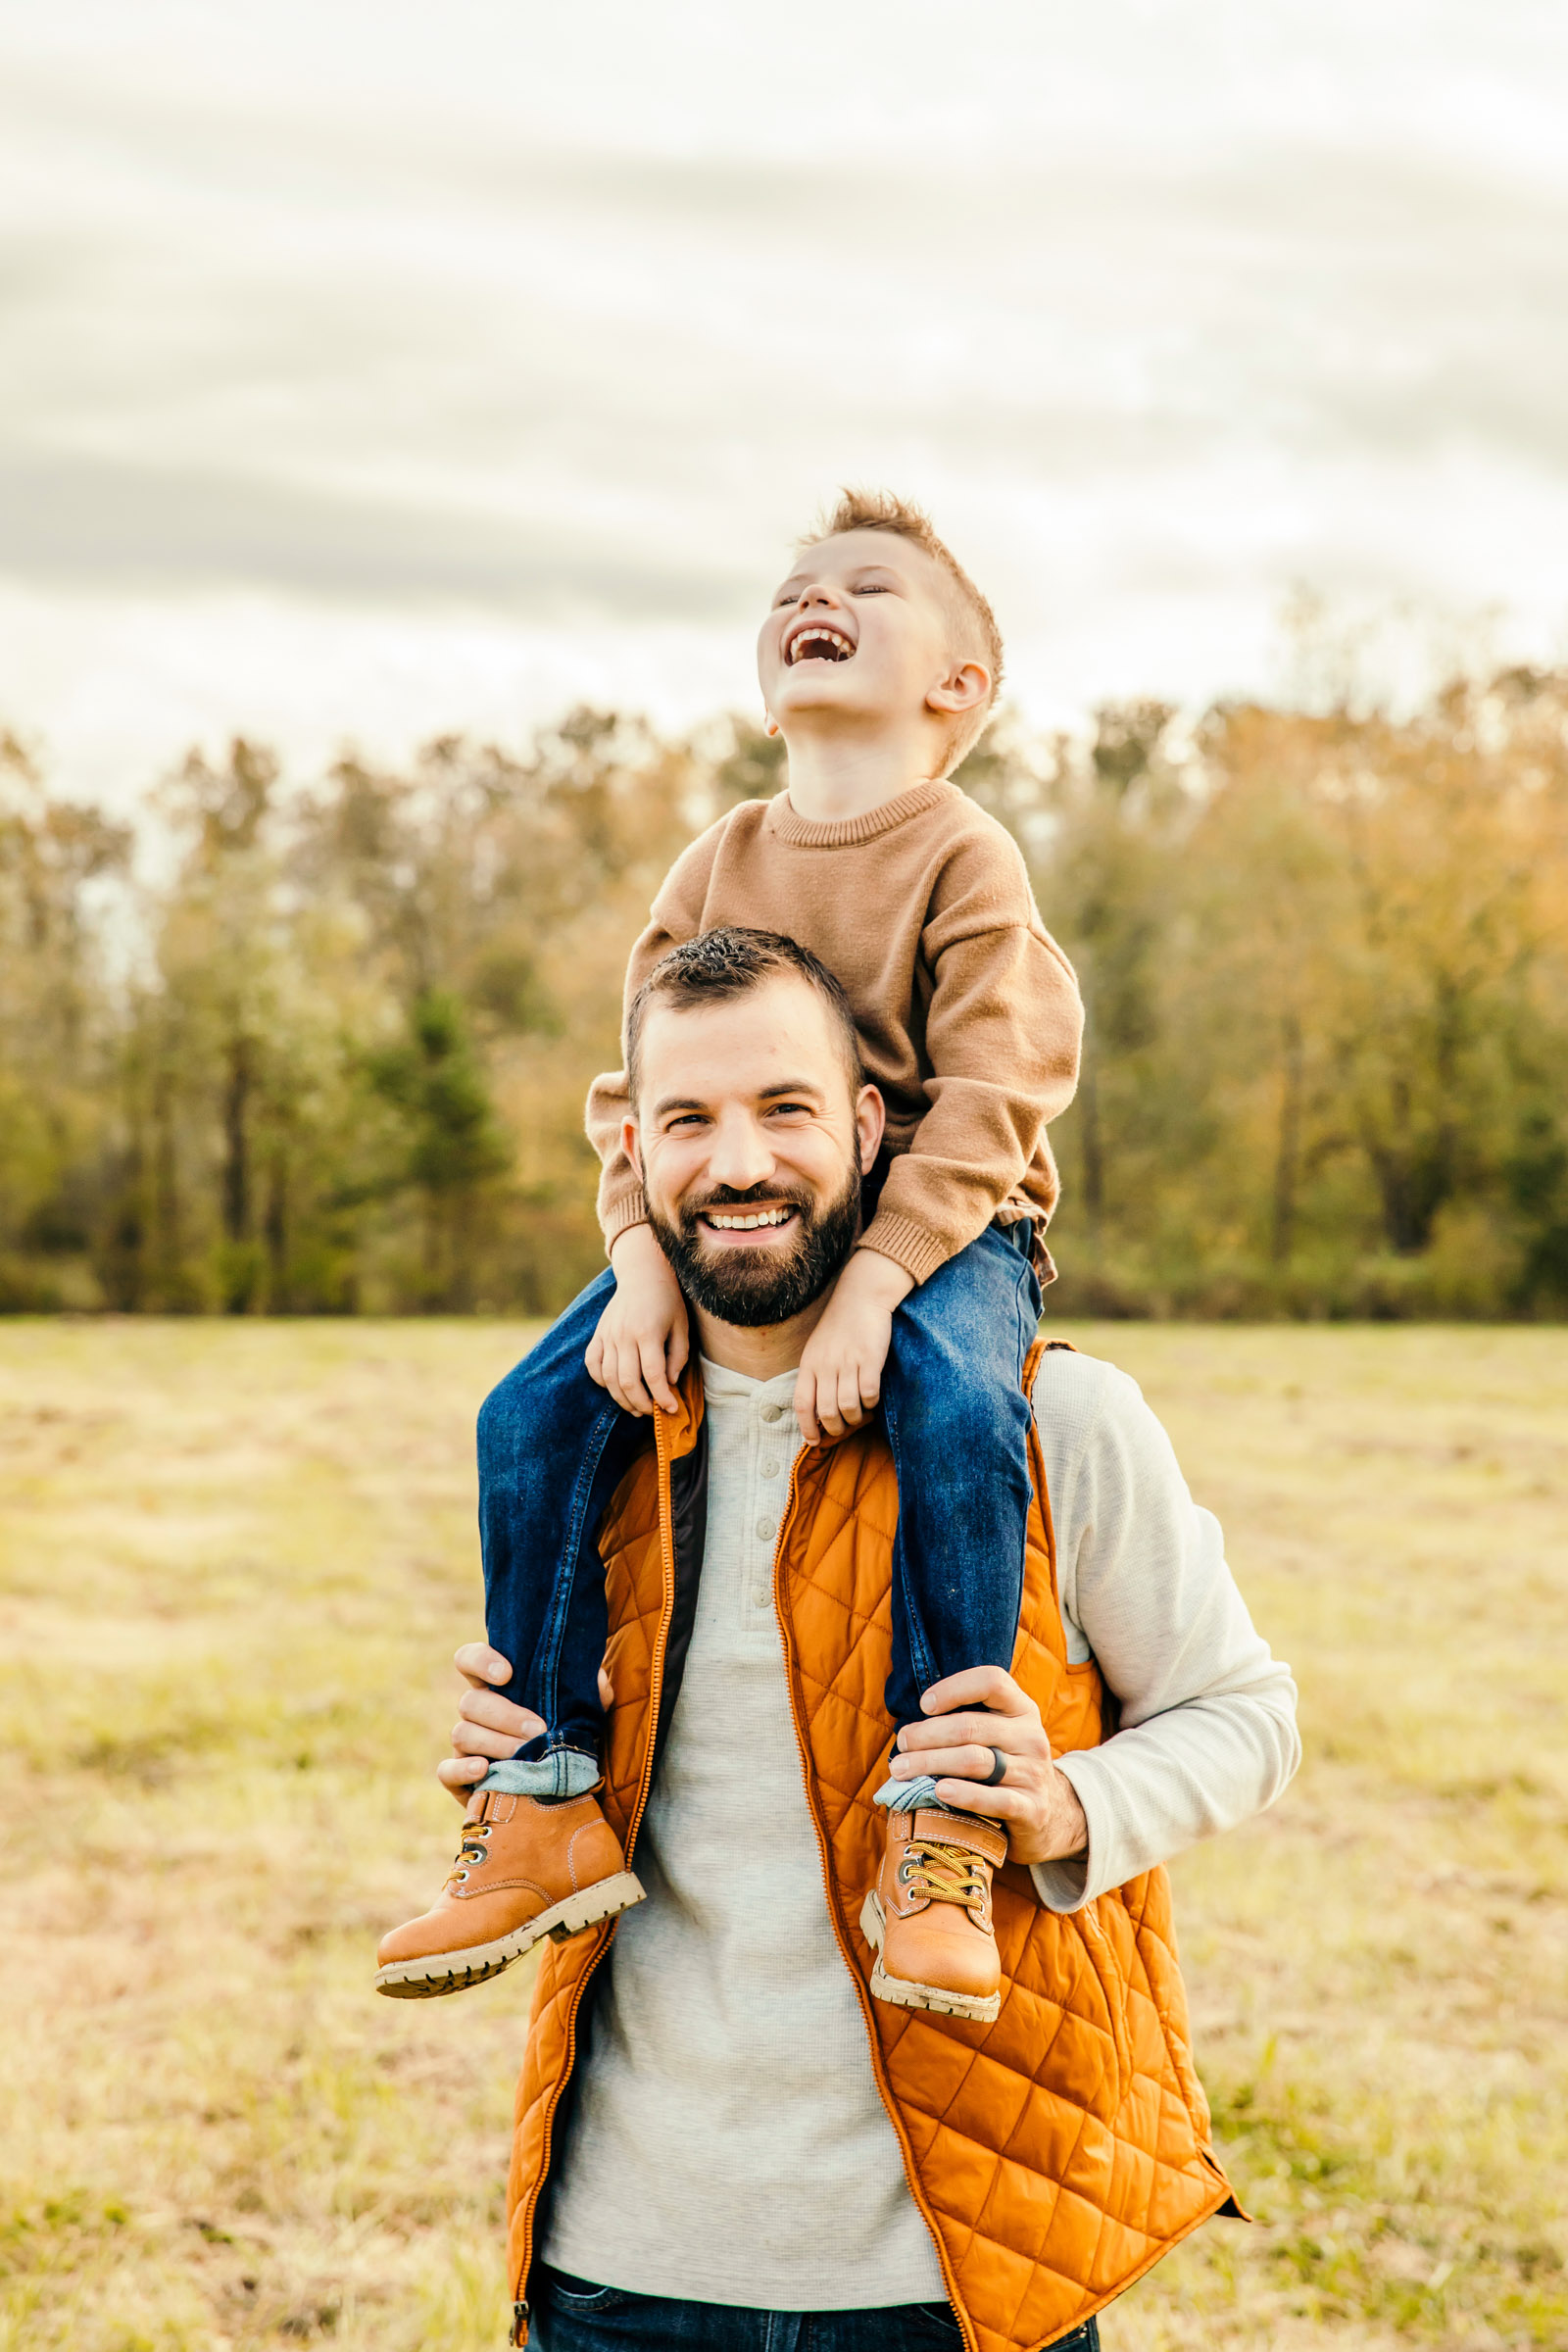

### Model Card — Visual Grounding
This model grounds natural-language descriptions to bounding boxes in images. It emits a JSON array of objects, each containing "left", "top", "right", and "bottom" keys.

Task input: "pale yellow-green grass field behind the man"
[{"left": 0, "top": 1322, "right": 1568, "bottom": 2352}]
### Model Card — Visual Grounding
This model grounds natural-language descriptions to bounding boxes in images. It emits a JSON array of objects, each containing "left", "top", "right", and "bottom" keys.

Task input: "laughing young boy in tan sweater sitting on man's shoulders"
[{"left": 376, "top": 494, "right": 1084, "bottom": 2018}]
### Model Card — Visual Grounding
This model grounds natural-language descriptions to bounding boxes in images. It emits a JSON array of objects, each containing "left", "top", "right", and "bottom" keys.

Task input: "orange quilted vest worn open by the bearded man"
[{"left": 508, "top": 1357, "right": 1237, "bottom": 2352}]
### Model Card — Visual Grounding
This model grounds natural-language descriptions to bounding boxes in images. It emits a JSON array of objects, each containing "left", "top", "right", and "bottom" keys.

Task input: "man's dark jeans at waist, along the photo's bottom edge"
[{"left": 529, "top": 2270, "right": 1101, "bottom": 2352}]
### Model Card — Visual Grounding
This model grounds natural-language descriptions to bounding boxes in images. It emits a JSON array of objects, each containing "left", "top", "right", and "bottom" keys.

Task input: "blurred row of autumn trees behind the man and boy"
[{"left": 0, "top": 670, "right": 1568, "bottom": 1317}]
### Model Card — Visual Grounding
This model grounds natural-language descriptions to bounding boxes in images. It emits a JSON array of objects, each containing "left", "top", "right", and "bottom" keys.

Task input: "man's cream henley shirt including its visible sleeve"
[{"left": 543, "top": 1350, "right": 1300, "bottom": 2310}]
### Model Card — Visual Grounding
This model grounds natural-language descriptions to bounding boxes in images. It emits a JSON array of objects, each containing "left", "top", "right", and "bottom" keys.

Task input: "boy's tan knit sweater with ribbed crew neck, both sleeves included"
[{"left": 588, "top": 783, "right": 1084, "bottom": 1282}]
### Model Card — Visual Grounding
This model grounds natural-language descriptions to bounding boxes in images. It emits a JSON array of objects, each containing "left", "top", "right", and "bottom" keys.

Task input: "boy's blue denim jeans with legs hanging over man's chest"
[{"left": 479, "top": 1221, "right": 1039, "bottom": 1757}]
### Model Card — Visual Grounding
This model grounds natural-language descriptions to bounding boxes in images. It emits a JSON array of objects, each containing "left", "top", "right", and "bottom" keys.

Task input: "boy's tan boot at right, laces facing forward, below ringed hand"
[{"left": 860, "top": 1806, "right": 1006, "bottom": 2025}]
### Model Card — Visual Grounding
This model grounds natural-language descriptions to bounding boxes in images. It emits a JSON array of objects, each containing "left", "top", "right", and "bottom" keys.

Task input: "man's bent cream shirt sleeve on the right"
[{"left": 1032, "top": 1352, "right": 1300, "bottom": 1910}]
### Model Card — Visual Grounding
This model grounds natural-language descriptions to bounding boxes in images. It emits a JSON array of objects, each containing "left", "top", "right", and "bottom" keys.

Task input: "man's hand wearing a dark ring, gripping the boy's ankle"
[{"left": 891, "top": 1665, "right": 1089, "bottom": 1863}]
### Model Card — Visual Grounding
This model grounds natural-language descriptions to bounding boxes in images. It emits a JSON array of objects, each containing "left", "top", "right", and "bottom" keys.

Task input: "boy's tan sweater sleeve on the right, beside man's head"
[{"left": 860, "top": 828, "right": 1084, "bottom": 1282}]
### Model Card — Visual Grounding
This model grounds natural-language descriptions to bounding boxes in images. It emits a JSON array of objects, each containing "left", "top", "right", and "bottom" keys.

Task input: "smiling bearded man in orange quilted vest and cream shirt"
[{"left": 442, "top": 934, "right": 1298, "bottom": 2352}]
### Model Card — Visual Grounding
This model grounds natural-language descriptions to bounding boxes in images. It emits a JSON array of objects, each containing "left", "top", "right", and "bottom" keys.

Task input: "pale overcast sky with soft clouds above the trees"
[{"left": 0, "top": 0, "right": 1568, "bottom": 802}]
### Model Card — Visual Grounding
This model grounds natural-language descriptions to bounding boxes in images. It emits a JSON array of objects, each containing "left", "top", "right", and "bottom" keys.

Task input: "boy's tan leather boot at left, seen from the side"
[{"left": 376, "top": 1789, "right": 642, "bottom": 2001}]
